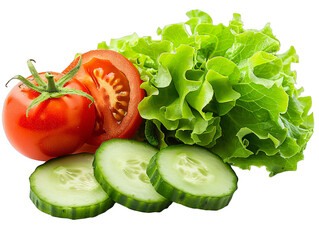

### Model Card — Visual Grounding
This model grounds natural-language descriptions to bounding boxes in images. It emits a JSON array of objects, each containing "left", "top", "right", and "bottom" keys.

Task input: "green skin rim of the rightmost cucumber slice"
[{"left": 146, "top": 145, "right": 238, "bottom": 210}]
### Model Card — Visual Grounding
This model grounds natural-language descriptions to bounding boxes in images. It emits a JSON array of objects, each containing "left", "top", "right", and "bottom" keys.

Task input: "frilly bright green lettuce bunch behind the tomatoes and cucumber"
[{"left": 98, "top": 10, "right": 314, "bottom": 176}]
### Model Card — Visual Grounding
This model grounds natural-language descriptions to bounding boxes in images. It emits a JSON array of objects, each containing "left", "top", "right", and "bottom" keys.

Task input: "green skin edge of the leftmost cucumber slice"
[{"left": 30, "top": 188, "right": 114, "bottom": 220}]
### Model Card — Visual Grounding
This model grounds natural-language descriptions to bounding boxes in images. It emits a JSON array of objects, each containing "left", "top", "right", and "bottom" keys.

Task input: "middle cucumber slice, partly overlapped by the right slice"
[{"left": 93, "top": 139, "right": 171, "bottom": 212}]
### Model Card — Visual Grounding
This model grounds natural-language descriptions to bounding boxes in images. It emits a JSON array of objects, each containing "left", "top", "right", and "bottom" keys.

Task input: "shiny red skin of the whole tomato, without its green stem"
[{"left": 2, "top": 73, "right": 95, "bottom": 161}]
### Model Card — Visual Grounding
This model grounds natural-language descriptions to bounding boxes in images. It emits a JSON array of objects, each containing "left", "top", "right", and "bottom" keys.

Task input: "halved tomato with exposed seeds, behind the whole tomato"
[{"left": 63, "top": 50, "right": 144, "bottom": 147}]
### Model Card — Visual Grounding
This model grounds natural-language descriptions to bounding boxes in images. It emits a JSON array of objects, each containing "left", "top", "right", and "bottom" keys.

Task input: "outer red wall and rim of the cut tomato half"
[{"left": 63, "top": 50, "right": 145, "bottom": 149}]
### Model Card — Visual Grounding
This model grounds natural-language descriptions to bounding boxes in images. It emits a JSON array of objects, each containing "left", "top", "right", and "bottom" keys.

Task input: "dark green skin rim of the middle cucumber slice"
[{"left": 93, "top": 139, "right": 172, "bottom": 212}]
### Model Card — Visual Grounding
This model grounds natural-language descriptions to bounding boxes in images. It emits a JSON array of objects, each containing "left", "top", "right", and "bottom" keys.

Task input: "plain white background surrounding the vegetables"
[{"left": 0, "top": 0, "right": 319, "bottom": 240}]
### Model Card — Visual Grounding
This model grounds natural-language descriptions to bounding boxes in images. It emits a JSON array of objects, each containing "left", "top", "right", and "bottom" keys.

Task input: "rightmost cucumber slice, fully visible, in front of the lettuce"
[{"left": 147, "top": 145, "right": 238, "bottom": 210}]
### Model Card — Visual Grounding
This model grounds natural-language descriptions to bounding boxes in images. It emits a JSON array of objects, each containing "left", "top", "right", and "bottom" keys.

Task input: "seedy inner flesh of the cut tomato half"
[{"left": 83, "top": 58, "right": 130, "bottom": 141}]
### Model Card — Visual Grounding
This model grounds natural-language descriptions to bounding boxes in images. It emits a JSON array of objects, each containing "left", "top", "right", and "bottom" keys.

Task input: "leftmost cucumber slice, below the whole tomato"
[{"left": 30, "top": 153, "right": 114, "bottom": 219}]
